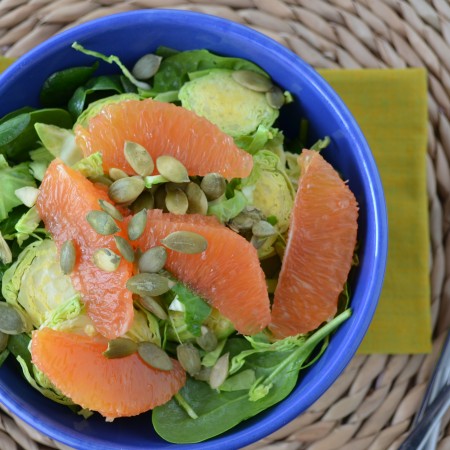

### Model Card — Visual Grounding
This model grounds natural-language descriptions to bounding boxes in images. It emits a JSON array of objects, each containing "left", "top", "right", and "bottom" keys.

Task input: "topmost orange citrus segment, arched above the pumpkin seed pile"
[{"left": 75, "top": 99, "right": 253, "bottom": 179}]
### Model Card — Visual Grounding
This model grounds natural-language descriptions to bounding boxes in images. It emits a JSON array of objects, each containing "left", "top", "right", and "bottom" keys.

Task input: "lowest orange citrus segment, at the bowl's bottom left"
[{"left": 31, "top": 328, "right": 186, "bottom": 419}]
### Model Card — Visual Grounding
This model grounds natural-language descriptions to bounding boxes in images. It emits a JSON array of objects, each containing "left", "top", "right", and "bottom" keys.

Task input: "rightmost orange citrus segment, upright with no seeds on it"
[{"left": 269, "top": 150, "right": 358, "bottom": 338}]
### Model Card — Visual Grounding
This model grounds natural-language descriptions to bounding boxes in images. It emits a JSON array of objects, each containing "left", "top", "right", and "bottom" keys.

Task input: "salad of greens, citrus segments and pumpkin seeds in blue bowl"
[{"left": 0, "top": 43, "right": 357, "bottom": 443}]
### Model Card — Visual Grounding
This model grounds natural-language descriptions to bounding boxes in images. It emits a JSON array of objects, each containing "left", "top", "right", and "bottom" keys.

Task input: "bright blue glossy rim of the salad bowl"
[{"left": 0, "top": 9, "right": 387, "bottom": 450}]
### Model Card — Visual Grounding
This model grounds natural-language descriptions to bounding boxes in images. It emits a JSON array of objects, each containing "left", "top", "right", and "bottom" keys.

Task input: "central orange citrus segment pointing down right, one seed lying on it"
[{"left": 137, "top": 210, "right": 270, "bottom": 335}]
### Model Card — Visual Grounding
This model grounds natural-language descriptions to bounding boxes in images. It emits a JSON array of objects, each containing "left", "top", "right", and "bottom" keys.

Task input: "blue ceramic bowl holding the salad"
[{"left": 0, "top": 10, "right": 387, "bottom": 450}]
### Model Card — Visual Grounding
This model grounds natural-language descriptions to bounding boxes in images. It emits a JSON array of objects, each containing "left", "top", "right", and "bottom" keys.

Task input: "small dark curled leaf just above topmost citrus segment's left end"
[{"left": 68, "top": 75, "right": 124, "bottom": 117}]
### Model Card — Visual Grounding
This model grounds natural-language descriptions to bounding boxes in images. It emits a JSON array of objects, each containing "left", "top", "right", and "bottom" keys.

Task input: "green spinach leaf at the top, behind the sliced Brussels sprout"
[{"left": 153, "top": 49, "right": 267, "bottom": 92}]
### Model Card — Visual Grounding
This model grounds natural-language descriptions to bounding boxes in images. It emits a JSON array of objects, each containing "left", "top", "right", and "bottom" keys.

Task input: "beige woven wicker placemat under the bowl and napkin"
[{"left": 0, "top": 0, "right": 450, "bottom": 450}]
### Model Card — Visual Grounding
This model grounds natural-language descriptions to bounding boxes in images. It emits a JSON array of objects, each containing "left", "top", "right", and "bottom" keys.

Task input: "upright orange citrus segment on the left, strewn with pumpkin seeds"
[{"left": 36, "top": 160, "right": 134, "bottom": 339}]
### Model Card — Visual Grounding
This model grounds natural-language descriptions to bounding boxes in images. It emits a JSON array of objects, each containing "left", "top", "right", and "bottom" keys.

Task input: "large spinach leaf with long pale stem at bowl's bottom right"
[{"left": 152, "top": 310, "right": 350, "bottom": 444}]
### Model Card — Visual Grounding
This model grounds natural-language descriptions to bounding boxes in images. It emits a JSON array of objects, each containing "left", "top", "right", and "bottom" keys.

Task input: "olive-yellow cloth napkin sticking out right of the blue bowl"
[{"left": 320, "top": 68, "right": 432, "bottom": 354}]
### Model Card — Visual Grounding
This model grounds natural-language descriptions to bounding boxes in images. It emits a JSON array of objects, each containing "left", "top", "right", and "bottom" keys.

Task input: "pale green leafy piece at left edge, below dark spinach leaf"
[{"left": 0, "top": 155, "right": 36, "bottom": 222}]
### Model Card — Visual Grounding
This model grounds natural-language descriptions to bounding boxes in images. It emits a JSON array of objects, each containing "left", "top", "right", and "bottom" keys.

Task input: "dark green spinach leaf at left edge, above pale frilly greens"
[{"left": 0, "top": 108, "right": 73, "bottom": 162}]
